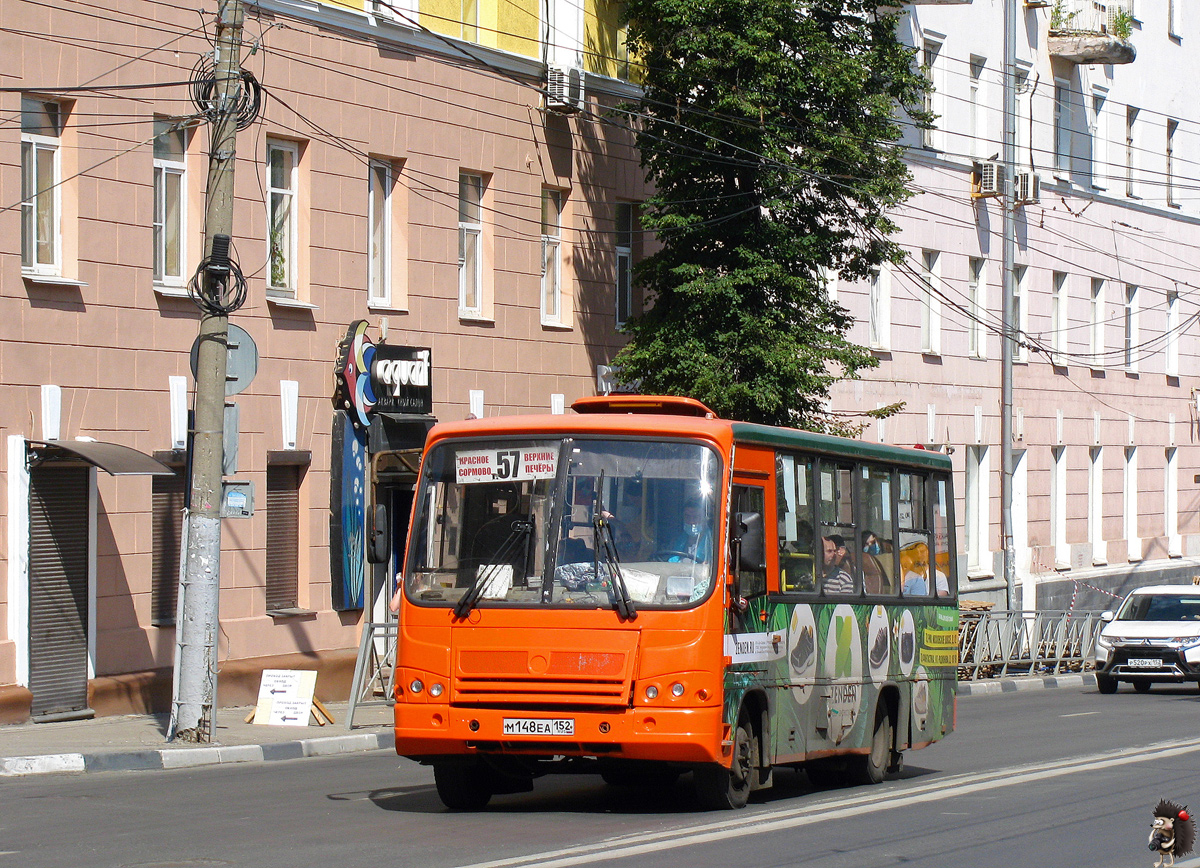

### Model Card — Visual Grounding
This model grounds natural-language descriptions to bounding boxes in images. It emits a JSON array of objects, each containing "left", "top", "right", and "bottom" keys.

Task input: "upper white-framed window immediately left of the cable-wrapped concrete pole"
[{"left": 154, "top": 118, "right": 187, "bottom": 287}]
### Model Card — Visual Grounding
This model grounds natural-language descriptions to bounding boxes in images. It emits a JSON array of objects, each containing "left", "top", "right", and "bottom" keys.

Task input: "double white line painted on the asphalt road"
[{"left": 461, "top": 738, "right": 1200, "bottom": 868}]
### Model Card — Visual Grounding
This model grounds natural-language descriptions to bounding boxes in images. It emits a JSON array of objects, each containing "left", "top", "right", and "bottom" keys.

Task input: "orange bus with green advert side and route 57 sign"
[{"left": 395, "top": 395, "right": 958, "bottom": 810}]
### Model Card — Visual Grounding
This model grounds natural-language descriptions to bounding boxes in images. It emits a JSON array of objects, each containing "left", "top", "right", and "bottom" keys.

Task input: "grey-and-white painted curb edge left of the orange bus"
[{"left": 0, "top": 731, "right": 396, "bottom": 778}]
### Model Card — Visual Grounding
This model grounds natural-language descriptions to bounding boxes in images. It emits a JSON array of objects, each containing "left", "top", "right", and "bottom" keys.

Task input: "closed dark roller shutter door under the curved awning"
[{"left": 29, "top": 467, "right": 91, "bottom": 717}]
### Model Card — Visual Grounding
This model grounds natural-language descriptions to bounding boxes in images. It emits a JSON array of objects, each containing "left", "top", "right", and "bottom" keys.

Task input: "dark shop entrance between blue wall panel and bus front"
[{"left": 367, "top": 449, "right": 421, "bottom": 623}]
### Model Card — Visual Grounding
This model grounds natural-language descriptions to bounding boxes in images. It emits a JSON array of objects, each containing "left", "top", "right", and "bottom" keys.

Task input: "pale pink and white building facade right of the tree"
[{"left": 834, "top": 0, "right": 1200, "bottom": 609}]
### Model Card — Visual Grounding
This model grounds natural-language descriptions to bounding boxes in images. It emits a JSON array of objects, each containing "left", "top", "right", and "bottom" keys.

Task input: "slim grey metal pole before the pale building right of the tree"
[{"left": 1000, "top": 0, "right": 1019, "bottom": 609}]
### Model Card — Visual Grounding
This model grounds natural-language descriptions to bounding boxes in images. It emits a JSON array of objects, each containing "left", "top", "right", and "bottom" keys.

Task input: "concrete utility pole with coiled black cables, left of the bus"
[{"left": 168, "top": 0, "right": 244, "bottom": 742}]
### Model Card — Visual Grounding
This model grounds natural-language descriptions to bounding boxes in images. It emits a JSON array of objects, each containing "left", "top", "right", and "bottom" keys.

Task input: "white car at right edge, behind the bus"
[{"left": 1096, "top": 585, "right": 1200, "bottom": 693}]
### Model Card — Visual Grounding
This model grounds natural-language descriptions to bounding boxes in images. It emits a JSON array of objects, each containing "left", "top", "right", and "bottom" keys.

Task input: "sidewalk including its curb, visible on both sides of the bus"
[{"left": 0, "top": 672, "right": 1096, "bottom": 778}]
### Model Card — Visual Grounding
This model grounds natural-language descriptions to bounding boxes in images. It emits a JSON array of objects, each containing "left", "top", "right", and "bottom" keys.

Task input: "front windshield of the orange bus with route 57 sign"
[{"left": 406, "top": 438, "right": 720, "bottom": 613}]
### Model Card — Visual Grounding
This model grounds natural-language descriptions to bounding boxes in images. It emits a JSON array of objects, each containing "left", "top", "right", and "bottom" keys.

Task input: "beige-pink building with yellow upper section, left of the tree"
[{"left": 0, "top": 0, "right": 644, "bottom": 722}]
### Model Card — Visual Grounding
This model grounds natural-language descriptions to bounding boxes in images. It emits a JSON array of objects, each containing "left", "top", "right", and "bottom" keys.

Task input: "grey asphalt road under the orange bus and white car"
[{"left": 0, "top": 687, "right": 1200, "bottom": 868}]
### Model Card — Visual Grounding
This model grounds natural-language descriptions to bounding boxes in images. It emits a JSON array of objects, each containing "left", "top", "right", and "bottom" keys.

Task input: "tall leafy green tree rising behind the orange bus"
[{"left": 616, "top": 0, "right": 930, "bottom": 432}]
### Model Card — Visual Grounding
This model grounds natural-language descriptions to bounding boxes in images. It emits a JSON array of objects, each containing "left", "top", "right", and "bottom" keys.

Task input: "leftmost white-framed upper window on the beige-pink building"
[{"left": 20, "top": 96, "right": 62, "bottom": 275}]
